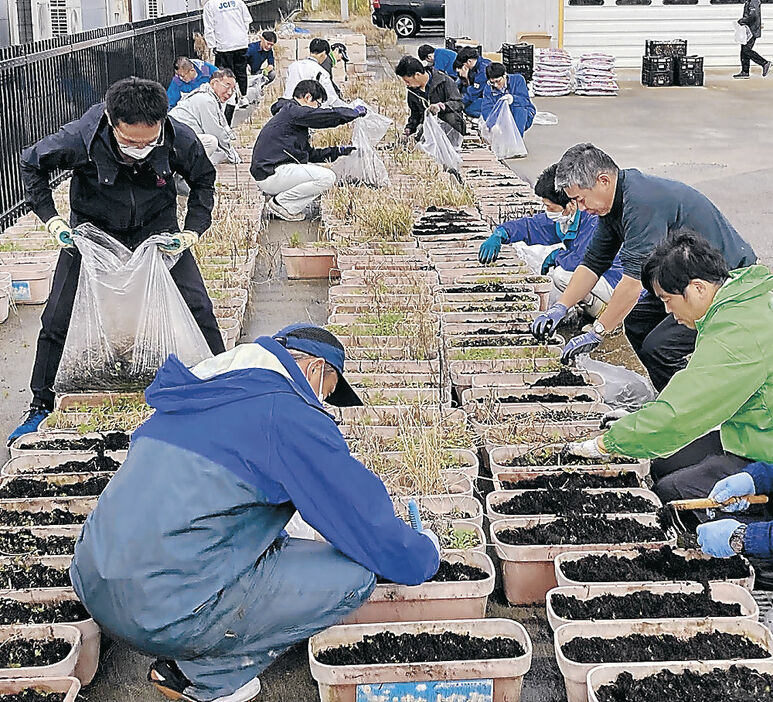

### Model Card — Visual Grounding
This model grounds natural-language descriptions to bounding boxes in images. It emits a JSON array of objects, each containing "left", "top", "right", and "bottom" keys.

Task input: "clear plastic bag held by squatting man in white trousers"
[{"left": 332, "top": 100, "right": 392, "bottom": 188}]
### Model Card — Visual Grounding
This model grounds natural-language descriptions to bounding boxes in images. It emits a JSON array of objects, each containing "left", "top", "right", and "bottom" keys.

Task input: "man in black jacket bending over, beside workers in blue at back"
[{"left": 395, "top": 56, "right": 467, "bottom": 136}]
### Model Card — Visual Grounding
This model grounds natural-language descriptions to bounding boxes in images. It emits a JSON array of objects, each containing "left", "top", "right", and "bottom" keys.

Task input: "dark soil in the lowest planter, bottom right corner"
[{"left": 596, "top": 665, "right": 773, "bottom": 702}]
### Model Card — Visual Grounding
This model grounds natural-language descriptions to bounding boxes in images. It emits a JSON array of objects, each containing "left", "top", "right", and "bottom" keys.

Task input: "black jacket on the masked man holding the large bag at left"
[{"left": 21, "top": 103, "right": 215, "bottom": 248}]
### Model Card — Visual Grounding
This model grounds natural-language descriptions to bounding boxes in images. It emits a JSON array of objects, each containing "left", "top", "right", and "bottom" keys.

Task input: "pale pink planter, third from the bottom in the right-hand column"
[{"left": 547, "top": 582, "right": 760, "bottom": 631}]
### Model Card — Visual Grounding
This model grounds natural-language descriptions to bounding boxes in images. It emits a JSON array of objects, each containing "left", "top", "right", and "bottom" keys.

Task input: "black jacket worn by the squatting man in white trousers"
[{"left": 250, "top": 98, "right": 359, "bottom": 181}]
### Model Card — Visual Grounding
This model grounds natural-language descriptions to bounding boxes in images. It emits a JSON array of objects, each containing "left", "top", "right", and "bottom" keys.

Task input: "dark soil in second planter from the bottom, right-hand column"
[{"left": 561, "top": 631, "right": 770, "bottom": 663}]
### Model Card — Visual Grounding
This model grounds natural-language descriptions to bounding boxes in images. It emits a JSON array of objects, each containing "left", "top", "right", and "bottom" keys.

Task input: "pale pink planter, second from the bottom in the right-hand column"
[{"left": 553, "top": 619, "right": 773, "bottom": 702}]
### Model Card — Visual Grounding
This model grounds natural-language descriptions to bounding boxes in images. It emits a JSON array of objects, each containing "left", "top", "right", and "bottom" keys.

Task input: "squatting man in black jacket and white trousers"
[{"left": 250, "top": 80, "right": 366, "bottom": 222}]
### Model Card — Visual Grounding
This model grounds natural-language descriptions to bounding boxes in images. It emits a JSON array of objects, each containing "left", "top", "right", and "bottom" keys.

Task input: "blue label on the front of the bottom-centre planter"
[{"left": 356, "top": 680, "right": 494, "bottom": 702}]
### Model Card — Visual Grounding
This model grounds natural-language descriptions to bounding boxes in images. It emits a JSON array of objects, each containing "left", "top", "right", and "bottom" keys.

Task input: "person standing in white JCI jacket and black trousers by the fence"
[{"left": 203, "top": 0, "right": 252, "bottom": 124}]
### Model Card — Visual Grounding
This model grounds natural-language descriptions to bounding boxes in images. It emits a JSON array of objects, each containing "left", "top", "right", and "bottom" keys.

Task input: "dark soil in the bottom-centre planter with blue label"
[{"left": 317, "top": 631, "right": 525, "bottom": 665}]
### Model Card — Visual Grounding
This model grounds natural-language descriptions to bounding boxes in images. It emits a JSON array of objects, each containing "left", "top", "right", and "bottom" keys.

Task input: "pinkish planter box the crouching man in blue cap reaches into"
[{"left": 345, "top": 551, "right": 494, "bottom": 624}]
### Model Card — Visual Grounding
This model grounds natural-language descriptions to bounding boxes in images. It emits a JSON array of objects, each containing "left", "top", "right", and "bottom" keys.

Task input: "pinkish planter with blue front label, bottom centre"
[{"left": 309, "top": 619, "right": 532, "bottom": 702}]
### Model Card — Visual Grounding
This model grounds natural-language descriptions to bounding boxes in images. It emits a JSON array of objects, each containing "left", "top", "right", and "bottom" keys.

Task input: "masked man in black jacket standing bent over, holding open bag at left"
[{"left": 9, "top": 78, "right": 225, "bottom": 443}]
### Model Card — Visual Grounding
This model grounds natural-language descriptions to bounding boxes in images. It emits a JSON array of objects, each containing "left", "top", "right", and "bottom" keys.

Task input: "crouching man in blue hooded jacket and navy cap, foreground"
[{"left": 70, "top": 324, "right": 440, "bottom": 702}]
